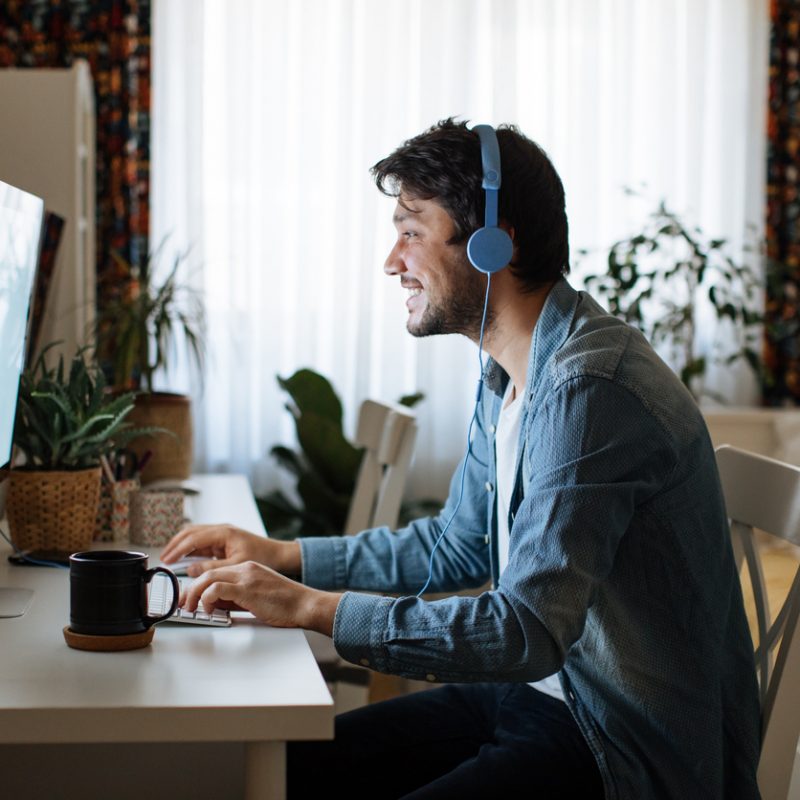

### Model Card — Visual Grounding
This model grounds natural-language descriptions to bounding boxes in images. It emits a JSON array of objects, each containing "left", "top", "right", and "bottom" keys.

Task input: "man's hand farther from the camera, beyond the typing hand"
[{"left": 161, "top": 525, "right": 302, "bottom": 578}]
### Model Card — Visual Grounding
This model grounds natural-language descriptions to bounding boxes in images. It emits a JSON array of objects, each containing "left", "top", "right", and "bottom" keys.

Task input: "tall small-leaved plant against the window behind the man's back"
[{"left": 580, "top": 195, "right": 763, "bottom": 400}]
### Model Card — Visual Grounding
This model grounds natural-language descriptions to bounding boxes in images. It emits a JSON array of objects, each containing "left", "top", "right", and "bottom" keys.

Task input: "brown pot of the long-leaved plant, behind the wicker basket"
[{"left": 128, "top": 392, "right": 194, "bottom": 483}]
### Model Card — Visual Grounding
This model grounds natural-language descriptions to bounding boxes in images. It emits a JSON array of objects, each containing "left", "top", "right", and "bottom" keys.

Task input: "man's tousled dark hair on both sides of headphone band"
[{"left": 370, "top": 118, "right": 569, "bottom": 291}]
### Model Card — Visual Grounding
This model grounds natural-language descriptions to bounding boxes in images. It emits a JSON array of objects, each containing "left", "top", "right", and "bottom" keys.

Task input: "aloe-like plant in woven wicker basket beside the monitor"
[{"left": 7, "top": 348, "right": 158, "bottom": 552}]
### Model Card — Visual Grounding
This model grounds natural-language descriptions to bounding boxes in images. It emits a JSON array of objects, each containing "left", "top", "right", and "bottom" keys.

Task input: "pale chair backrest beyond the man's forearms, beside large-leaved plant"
[{"left": 344, "top": 400, "right": 417, "bottom": 535}]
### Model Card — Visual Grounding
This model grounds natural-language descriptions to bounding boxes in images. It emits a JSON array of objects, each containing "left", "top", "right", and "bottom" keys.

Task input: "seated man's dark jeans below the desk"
[{"left": 287, "top": 683, "right": 603, "bottom": 800}]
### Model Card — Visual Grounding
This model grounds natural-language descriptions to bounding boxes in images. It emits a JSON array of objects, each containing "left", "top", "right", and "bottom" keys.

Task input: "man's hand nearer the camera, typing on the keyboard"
[{"left": 180, "top": 561, "right": 341, "bottom": 636}]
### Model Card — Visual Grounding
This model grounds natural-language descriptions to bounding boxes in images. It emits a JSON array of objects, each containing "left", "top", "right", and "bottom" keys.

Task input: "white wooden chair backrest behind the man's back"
[{"left": 716, "top": 445, "right": 800, "bottom": 800}]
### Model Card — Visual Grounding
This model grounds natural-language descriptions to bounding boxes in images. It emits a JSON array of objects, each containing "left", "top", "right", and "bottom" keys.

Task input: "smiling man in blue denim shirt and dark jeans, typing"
[{"left": 163, "top": 120, "right": 758, "bottom": 800}]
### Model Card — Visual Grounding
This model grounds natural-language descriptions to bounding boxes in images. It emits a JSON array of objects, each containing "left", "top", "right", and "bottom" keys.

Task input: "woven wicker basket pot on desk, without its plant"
[{"left": 6, "top": 467, "right": 100, "bottom": 552}]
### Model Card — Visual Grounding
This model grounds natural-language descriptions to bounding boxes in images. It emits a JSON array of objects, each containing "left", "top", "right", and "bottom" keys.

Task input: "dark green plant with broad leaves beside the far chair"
[{"left": 256, "top": 369, "right": 428, "bottom": 538}]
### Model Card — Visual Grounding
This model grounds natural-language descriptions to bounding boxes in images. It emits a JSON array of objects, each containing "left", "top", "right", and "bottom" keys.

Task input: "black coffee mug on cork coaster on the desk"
[{"left": 69, "top": 550, "right": 180, "bottom": 636}]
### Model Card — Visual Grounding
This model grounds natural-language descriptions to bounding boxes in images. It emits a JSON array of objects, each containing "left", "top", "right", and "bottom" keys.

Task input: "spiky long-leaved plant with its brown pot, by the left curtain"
[{"left": 95, "top": 252, "right": 205, "bottom": 481}]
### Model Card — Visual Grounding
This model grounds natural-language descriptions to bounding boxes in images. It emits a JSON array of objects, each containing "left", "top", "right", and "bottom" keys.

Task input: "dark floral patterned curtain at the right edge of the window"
[{"left": 764, "top": 0, "right": 800, "bottom": 405}]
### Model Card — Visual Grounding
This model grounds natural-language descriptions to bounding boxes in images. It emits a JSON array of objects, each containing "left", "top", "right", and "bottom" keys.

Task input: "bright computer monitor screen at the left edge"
[{"left": 0, "top": 181, "right": 44, "bottom": 466}]
